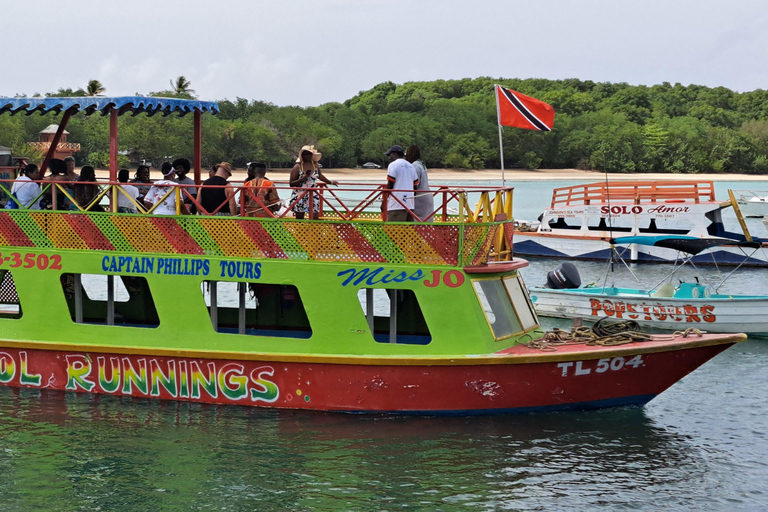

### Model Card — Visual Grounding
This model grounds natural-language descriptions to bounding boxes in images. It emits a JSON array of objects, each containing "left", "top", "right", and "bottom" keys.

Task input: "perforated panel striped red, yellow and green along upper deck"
[{"left": 0, "top": 210, "right": 500, "bottom": 266}]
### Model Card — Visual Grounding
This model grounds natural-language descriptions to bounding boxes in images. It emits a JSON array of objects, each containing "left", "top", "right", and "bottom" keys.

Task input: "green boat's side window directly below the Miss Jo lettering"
[{"left": 357, "top": 288, "right": 432, "bottom": 345}]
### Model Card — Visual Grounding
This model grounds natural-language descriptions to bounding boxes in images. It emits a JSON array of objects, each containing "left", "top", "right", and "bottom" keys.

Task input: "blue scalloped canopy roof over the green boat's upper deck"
[{"left": 0, "top": 96, "right": 219, "bottom": 116}]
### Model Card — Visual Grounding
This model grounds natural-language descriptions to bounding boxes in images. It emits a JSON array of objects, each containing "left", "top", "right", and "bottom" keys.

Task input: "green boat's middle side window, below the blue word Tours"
[{"left": 201, "top": 281, "right": 312, "bottom": 339}]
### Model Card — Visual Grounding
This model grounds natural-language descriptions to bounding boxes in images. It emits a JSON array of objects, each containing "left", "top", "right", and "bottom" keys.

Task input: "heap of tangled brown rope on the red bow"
[{"left": 524, "top": 318, "right": 702, "bottom": 352}]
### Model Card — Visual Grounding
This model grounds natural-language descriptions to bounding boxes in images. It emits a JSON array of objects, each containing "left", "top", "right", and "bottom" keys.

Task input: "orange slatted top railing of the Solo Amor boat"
[{"left": 550, "top": 180, "right": 716, "bottom": 208}]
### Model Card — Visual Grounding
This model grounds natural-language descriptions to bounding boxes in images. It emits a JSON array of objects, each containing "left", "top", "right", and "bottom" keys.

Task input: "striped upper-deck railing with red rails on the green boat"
[{"left": 0, "top": 180, "right": 513, "bottom": 267}]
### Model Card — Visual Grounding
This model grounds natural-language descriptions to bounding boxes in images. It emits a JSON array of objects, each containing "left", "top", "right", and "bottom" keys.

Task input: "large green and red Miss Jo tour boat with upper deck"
[{"left": 0, "top": 97, "right": 745, "bottom": 414}]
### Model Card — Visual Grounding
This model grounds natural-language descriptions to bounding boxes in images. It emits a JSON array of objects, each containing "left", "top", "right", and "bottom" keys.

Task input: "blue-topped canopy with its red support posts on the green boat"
[{"left": 0, "top": 96, "right": 219, "bottom": 184}]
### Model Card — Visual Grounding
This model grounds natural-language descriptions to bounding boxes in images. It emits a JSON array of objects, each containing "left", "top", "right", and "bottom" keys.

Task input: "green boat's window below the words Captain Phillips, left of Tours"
[{"left": 61, "top": 274, "right": 160, "bottom": 328}]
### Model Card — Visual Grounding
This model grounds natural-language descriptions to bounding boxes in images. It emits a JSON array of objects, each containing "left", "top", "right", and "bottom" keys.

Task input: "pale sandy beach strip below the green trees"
[{"left": 94, "top": 168, "right": 768, "bottom": 183}]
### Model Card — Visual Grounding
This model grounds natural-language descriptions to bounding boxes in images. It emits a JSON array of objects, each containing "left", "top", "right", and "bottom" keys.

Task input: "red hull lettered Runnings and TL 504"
[{"left": 0, "top": 335, "right": 743, "bottom": 414}]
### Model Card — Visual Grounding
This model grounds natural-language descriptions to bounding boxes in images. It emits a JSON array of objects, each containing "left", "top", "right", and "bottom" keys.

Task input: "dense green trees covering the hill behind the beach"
[{"left": 0, "top": 76, "right": 768, "bottom": 173}]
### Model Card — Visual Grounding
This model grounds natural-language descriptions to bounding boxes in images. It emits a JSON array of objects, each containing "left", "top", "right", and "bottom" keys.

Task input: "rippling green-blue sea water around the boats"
[{"left": 0, "top": 178, "right": 768, "bottom": 511}]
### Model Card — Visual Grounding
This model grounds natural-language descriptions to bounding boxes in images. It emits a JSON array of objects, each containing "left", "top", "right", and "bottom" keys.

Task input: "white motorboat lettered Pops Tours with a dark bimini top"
[{"left": 529, "top": 236, "right": 768, "bottom": 337}]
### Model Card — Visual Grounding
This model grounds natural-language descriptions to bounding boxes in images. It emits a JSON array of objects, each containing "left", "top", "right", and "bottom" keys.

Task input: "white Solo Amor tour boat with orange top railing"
[{"left": 515, "top": 181, "right": 768, "bottom": 266}]
